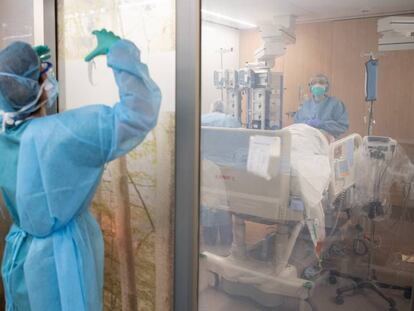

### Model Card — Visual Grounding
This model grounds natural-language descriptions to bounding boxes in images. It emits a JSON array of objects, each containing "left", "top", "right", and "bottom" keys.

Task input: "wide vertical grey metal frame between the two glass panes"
[{"left": 174, "top": 0, "right": 201, "bottom": 311}]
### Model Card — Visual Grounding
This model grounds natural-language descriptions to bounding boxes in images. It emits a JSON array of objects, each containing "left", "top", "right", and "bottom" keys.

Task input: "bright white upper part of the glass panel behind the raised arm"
[{"left": 58, "top": 0, "right": 175, "bottom": 112}]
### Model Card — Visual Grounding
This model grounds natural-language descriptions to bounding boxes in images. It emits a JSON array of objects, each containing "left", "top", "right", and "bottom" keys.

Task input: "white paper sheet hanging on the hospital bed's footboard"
[{"left": 247, "top": 136, "right": 281, "bottom": 180}]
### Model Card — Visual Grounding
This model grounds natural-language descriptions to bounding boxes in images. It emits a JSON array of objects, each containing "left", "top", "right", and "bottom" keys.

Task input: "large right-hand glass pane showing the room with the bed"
[{"left": 199, "top": 0, "right": 414, "bottom": 311}]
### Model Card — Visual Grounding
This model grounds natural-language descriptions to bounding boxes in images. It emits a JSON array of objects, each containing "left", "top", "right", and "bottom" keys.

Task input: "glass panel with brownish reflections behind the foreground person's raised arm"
[{"left": 58, "top": 0, "right": 175, "bottom": 310}]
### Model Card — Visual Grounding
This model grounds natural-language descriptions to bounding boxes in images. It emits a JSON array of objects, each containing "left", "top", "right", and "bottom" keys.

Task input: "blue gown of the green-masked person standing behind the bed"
[{"left": 295, "top": 96, "right": 349, "bottom": 138}]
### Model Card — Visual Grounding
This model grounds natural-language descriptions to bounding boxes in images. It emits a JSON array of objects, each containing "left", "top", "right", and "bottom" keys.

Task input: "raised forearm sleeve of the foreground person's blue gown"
[{"left": 99, "top": 40, "right": 161, "bottom": 162}]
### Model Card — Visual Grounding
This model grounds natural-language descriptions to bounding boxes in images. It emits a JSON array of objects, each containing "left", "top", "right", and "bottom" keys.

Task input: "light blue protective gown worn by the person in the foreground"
[{"left": 0, "top": 40, "right": 161, "bottom": 311}]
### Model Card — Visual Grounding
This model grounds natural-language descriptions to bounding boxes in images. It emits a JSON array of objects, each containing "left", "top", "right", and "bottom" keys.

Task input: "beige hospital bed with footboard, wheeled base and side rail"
[{"left": 201, "top": 127, "right": 362, "bottom": 309}]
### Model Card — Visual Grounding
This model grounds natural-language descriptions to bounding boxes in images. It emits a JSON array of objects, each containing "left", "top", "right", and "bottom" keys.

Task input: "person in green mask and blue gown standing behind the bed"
[{"left": 295, "top": 74, "right": 349, "bottom": 138}]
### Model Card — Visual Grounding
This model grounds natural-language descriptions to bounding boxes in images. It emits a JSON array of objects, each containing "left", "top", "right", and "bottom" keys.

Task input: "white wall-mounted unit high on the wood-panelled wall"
[{"left": 378, "top": 16, "right": 414, "bottom": 51}]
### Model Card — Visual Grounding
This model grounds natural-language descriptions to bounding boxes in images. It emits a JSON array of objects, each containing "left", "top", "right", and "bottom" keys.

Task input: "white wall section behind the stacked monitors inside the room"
[{"left": 201, "top": 22, "right": 240, "bottom": 113}]
